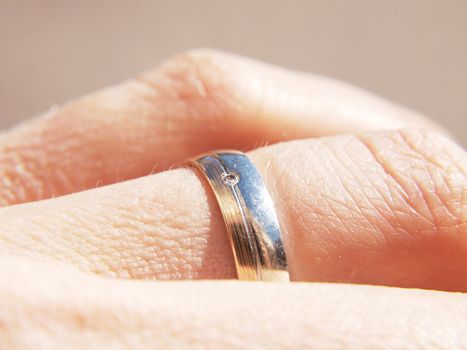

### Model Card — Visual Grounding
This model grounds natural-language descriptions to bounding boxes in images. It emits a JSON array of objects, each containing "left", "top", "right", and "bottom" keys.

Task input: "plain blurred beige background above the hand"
[{"left": 0, "top": 0, "right": 467, "bottom": 145}]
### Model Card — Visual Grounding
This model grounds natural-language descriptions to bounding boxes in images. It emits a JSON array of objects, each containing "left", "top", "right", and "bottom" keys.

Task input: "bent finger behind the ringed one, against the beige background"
[{"left": 0, "top": 51, "right": 442, "bottom": 205}]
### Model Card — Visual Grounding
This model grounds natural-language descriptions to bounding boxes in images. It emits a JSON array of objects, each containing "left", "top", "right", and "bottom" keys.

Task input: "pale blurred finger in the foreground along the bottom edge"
[{"left": 0, "top": 256, "right": 467, "bottom": 349}]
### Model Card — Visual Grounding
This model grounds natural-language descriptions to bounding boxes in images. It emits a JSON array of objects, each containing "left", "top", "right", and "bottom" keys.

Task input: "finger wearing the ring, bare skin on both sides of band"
[{"left": 0, "top": 130, "right": 467, "bottom": 291}]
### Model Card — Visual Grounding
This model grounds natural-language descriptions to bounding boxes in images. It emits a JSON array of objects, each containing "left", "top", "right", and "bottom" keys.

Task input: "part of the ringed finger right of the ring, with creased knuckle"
[{"left": 253, "top": 130, "right": 467, "bottom": 289}]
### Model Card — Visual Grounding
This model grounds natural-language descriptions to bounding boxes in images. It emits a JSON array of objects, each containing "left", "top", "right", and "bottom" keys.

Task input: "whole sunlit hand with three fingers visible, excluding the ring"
[{"left": 0, "top": 51, "right": 467, "bottom": 349}]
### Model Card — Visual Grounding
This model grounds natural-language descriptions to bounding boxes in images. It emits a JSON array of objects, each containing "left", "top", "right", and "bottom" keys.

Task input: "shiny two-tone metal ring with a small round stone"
[{"left": 189, "top": 151, "right": 290, "bottom": 281}]
